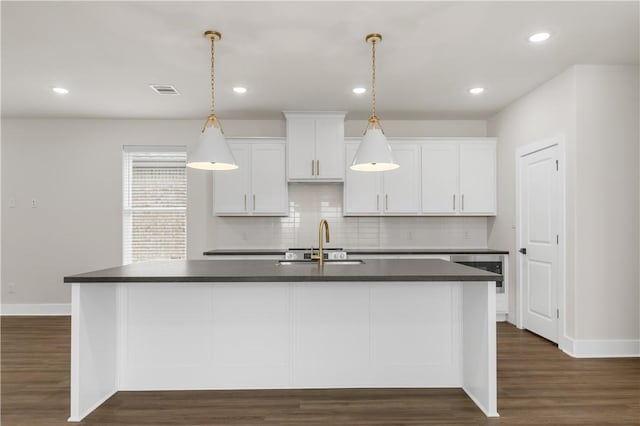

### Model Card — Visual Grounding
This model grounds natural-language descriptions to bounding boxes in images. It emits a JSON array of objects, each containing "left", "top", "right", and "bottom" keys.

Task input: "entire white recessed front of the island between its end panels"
[{"left": 119, "top": 282, "right": 464, "bottom": 390}]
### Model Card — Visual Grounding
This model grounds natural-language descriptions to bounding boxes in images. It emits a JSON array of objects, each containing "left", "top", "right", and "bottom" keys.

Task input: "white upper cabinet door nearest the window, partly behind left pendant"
[{"left": 213, "top": 144, "right": 250, "bottom": 215}]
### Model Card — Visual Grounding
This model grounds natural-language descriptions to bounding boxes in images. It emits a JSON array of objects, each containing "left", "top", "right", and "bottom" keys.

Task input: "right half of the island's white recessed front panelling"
[{"left": 292, "top": 282, "right": 462, "bottom": 388}]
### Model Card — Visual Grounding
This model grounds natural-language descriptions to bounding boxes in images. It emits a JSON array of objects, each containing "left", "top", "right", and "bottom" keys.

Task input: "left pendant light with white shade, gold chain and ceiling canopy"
[{"left": 187, "top": 31, "right": 238, "bottom": 170}]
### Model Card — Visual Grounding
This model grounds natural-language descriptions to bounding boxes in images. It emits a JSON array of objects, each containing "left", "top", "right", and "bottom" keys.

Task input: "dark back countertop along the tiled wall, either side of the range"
[{"left": 203, "top": 248, "right": 509, "bottom": 256}]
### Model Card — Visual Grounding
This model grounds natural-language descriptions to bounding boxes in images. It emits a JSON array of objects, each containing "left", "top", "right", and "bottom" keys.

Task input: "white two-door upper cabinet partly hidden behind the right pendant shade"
[{"left": 344, "top": 143, "right": 420, "bottom": 216}]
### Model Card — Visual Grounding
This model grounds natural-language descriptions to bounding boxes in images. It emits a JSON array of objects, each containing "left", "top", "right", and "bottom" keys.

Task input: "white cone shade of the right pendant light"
[{"left": 350, "top": 128, "right": 400, "bottom": 172}]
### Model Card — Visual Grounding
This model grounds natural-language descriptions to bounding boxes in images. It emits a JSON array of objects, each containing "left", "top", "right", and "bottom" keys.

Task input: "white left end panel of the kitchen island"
[{"left": 69, "top": 283, "right": 118, "bottom": 422}]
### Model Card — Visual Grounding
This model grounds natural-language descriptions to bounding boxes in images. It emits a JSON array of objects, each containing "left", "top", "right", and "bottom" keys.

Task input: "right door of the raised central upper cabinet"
[{"left": 315, "top": 118, "right": 345, "bottom": 180}]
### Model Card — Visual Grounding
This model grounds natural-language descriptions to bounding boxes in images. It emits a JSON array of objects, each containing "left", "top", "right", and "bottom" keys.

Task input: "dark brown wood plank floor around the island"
[{"left": 1, "top": 317, "right": 640, "bottom": 426}]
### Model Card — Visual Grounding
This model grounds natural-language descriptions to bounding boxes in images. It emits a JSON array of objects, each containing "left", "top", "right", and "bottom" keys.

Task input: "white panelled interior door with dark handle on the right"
[{"left": 519, "top": 145, "right": 559, "bottom": 343}]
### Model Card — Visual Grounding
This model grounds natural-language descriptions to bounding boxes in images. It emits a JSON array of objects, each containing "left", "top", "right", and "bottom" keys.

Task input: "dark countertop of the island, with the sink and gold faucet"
[{"left": 64, "top": 259, "right": 502, "bottom": 283}]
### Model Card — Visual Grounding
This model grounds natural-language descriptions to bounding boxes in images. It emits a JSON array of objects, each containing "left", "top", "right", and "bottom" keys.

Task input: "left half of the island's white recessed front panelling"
[{"left": 120, "top": 282, "right": 290, "bottom": 390}]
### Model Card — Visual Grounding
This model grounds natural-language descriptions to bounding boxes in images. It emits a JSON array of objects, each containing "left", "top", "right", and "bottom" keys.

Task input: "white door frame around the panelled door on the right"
[{"left": 515, "top": 134, "right": 569, "bottom": 349}]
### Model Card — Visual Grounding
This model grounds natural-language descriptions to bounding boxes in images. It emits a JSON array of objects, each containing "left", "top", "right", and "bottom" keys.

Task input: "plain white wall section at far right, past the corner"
[{"left": 575, "top": 65, "right": 640, "bottom": 339}]
